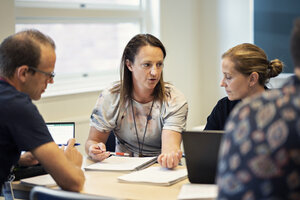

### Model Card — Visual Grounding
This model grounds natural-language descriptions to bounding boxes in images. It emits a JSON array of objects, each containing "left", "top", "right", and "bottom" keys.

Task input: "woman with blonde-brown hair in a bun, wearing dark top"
[{"left": 204, "top": 43, "right": 283, "bottom": 130}]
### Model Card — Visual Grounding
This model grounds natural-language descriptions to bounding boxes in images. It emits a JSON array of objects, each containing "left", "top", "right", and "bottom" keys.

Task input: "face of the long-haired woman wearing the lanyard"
[{"left": 126, "top": 45, "right": 164, "bottom": 92}]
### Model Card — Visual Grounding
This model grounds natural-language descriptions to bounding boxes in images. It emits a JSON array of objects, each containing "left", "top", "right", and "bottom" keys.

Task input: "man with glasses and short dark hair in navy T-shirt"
[{"left": 0, "top": 30, "right": 85, "bottom": 191}]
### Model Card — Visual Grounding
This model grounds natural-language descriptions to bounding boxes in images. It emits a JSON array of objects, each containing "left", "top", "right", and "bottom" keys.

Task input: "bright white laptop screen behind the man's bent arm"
[{"left": 46, "top": 122, "right": 75, "bottom": 145}]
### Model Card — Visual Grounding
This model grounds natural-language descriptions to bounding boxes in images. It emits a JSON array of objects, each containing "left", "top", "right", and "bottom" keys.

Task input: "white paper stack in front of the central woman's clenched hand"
[{"left": 118, "top": 167, "right": 187, "bottom": 186}]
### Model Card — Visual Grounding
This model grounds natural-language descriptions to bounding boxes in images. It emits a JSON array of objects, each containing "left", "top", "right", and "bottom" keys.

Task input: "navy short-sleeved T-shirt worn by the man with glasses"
[{"left": 0, "top": 80, "right": 53, "bottom": 186}]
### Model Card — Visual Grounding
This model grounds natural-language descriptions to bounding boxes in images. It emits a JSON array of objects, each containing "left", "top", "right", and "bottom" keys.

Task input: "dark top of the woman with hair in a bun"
[{"left": 204, "top": 97, "right": 241, "bottom": 130}]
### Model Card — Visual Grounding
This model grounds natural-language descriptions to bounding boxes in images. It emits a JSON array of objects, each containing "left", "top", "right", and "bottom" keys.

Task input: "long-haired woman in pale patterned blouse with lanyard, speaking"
[{"left": 85, "top": 34, "right": 188, "bottom": 168}]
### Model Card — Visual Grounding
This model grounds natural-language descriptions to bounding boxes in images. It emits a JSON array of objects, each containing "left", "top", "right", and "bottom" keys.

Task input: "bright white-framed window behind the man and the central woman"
[{"left": 15, "top": 0, "right": 159, "bottom": 96}]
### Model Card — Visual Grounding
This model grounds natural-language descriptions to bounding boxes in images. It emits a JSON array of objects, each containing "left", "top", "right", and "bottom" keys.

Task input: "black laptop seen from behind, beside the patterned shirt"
[{"left": 182, "top": 130, "right": 224, "bottom": 184}]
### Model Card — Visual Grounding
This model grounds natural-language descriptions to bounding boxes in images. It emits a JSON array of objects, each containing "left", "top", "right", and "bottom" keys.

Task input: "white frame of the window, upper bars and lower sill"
[{"left": 15, "top": 0, "right": 159, "bottom": 97}]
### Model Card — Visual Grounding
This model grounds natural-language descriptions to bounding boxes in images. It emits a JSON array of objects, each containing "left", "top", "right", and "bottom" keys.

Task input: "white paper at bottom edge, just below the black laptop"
[{"left": 178, "top": 183, "right": 218, "bottom": 200}]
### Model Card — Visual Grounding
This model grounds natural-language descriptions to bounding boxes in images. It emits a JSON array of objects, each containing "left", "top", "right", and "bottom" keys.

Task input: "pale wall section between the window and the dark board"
[{"left": 161, "top": 0, "right": 252, "bottom": 129}]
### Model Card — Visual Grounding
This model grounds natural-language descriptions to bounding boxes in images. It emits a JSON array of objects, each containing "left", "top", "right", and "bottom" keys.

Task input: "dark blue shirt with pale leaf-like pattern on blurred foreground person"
[{"left": 217, "top": 76, "right": 300, "bottom": 200}]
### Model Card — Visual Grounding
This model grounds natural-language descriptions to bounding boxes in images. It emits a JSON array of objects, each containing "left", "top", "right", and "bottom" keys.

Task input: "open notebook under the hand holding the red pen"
[{"left": 85, "top": 156, "right": 157, "bottom": 171}]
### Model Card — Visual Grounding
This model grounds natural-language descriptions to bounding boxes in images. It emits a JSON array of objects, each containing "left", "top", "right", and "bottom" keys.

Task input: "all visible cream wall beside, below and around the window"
[{"left": 0, "top": 0, "right": 252, "bottom": 155}]
